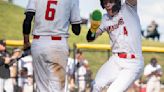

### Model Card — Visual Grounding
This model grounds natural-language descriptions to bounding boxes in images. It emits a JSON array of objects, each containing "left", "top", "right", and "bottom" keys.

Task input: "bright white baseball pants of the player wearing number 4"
[{"left": 92, "top": 55, "right": 144, "bottom": 92}]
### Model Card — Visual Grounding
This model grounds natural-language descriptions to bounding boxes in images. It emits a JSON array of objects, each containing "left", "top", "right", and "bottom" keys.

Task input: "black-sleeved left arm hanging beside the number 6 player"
[{"left": 23, "top": 12, "right": 35, "bottom": 49}]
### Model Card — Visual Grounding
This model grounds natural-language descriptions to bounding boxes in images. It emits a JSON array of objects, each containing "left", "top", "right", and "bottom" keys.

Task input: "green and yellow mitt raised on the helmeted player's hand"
[{"left": 90, "top": 10, "right": 102, "bottom": 33}]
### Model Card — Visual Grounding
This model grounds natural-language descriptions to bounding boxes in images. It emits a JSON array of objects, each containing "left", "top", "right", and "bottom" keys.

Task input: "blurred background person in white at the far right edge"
[{"left": 144, "top": 58, "right": 162, "bottom": 92}]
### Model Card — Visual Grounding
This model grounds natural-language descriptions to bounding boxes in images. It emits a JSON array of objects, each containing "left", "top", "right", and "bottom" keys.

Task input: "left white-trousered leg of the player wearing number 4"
[{"left": 92, "top": 55, "right": 120, "bottom": 92}]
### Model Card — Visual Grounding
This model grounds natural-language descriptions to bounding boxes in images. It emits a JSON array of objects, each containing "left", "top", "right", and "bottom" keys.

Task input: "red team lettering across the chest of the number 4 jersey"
[{"left": 105, "top": 17, "right": 124, "bottom": 32}]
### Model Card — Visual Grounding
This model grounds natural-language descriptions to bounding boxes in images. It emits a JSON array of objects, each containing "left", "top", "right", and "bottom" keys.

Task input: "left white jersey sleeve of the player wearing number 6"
[{"left": 25, "top": 0, "right": 36, "bottom": 12}]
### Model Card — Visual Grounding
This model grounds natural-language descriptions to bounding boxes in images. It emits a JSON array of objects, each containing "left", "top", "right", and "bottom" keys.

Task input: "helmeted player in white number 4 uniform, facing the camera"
[{"left": 87, "top": 0, "right": 144, "bottom": 92}]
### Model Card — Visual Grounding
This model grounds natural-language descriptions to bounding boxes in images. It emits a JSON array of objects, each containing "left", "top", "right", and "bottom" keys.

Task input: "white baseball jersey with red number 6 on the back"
[{"left": 26, "top": 0, "right": 81, "bottom": 37}]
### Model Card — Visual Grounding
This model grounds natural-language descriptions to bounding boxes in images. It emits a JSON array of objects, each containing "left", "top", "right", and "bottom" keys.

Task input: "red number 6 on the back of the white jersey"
[{"left": 45, "top": 1, "right": 57, "bottom": 21}]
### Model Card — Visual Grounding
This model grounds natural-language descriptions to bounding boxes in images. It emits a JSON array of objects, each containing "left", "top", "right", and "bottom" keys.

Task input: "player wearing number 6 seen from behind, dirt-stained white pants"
[{"left": 23, "top": 0, "right": 81, "bottom": 92}]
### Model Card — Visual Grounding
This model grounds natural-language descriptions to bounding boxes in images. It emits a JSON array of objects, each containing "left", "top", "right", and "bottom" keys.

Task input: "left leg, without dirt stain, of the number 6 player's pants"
[{"left": 31, "top": 39, "right": 53, "bottom": 92}]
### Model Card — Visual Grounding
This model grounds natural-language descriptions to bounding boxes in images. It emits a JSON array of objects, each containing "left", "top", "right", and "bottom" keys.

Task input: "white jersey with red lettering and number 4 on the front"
[{"left": 97, "top": 2, "right": 142, "bottom": 56}]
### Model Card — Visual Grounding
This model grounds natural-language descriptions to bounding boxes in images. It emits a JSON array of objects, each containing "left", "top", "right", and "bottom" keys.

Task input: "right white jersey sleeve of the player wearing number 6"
[{"left": 70, "top": 0, "right": 82, "bottom": 24}]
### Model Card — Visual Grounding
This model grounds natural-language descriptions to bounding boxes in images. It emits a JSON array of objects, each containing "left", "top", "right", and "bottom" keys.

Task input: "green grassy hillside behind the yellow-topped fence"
[{"left": 0, "top": 0, "right": 164, "bottom": 82}]
